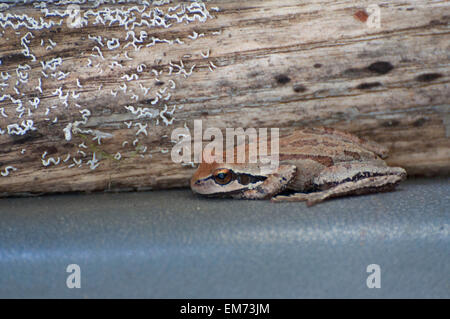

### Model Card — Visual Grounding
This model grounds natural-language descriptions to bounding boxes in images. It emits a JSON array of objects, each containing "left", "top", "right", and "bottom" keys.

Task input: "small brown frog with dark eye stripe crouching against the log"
[{"left": 191, "top": 128, "right": 406, "bottom": 205}]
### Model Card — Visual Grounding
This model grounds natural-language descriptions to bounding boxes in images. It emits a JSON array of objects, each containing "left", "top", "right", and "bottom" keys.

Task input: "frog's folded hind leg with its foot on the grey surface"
[{"left": 272, "top": 162, "right": 406, "bottom": 206}]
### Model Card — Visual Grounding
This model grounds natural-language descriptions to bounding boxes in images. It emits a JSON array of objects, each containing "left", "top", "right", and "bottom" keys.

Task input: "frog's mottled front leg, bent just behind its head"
[{"left": 233, "top": 165, "right": 297, "bottom": 199}]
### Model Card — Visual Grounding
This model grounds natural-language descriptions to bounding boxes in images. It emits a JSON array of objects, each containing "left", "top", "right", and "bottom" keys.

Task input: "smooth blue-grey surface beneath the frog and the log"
[{"left": 0, "top": 179, "right": 450, "bottom": 298}]
